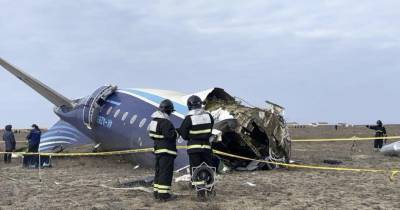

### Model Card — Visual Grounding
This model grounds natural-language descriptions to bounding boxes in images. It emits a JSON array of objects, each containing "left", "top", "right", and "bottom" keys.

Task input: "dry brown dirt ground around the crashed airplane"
[{"left": 0, "top": 127, "right": 400, "bottom": 210}]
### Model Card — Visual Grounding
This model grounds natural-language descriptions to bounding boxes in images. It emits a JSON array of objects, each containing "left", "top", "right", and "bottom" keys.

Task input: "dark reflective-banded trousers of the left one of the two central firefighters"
[{"left": 154, "top": 154, "right": 175, "bottom": 198}]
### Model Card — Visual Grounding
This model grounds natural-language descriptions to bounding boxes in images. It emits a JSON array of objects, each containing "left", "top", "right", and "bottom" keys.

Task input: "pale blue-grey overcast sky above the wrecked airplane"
[{"left": 0, "top": 0, "right": 400, "bottom": 127}]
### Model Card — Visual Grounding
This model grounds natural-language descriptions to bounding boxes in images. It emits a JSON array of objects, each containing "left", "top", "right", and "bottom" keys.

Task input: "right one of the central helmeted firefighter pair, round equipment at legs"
[{"left": 179, "top": 95, "right": 214, "bottom": 198}]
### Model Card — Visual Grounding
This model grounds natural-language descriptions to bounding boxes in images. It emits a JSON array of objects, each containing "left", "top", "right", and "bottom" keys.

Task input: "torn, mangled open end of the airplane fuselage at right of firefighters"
[{"left": 205, "top": 89, "right": 291, "bottom": 170}]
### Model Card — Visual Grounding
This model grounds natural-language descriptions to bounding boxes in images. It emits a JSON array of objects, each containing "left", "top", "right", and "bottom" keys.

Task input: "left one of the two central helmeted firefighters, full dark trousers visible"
[{"left": 148, "top": 99, "right": 178, "bottom": 201}]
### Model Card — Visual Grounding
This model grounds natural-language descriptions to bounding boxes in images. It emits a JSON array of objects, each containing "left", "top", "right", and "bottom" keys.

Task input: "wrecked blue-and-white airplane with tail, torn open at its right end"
[{"left": 0, "top": 58, "right": 291, "bottom": 170}]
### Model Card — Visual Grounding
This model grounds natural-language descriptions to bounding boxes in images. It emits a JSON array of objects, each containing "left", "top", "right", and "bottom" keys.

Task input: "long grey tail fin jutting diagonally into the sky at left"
[{"left": 0, "top": 58, "right": 74, "bottom": 108}]
